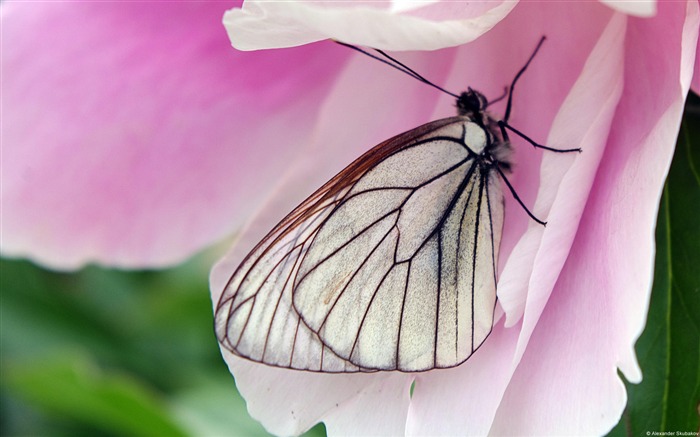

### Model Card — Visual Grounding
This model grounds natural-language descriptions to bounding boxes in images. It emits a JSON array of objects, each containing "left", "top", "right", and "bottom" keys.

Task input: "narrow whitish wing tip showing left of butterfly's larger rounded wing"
[{"left": 215, "top": 179, "right": 359, "bottom": 372}]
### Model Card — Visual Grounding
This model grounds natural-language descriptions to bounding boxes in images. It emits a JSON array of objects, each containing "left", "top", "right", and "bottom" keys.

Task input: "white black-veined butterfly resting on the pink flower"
[{"left": 215, "top": 37, "right": 581, "bottom": 373}]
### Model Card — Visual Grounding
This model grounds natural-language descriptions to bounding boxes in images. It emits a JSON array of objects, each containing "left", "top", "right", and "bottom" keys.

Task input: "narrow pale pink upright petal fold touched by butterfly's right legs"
[{"left": 501, "top": 10, "right": 625, "bottom": 363}]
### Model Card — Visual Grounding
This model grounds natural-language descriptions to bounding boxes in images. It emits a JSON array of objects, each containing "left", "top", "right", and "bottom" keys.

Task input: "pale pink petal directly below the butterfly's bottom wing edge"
[{"left": 224, "top": 352, "right": 413, "bottom": 435}]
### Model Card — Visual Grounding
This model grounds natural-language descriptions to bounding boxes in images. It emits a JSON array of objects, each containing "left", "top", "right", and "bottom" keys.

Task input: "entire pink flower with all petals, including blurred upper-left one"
[{"left": 5, "top": 1, "right": 700, "bottom": 435}]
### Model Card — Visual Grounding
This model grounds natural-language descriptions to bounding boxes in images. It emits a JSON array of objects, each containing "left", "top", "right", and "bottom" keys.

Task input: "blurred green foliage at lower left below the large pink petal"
[{"left": 0, "top": 249, "right": 325, "bottom": 436}]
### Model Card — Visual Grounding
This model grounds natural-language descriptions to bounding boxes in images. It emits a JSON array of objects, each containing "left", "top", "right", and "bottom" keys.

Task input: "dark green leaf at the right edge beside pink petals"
[{"left": 610, "top": 96, "right": 700, "bottom": 436}]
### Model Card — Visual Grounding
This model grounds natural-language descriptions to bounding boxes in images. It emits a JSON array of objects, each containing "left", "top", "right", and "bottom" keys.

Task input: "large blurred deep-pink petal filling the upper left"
[{"left": 1, "top": 2, "right": 348, "bottom": 268}]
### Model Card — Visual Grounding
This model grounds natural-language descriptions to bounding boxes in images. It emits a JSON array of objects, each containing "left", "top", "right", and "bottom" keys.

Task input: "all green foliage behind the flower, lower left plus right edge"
[{"left": 0, "top": 96, "right": 700, "bottom": 437}]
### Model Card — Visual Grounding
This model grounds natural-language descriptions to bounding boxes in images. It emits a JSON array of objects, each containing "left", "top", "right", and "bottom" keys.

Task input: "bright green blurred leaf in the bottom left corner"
[{"left": 3, "top": 353, "right": 186, "bottom": 437}]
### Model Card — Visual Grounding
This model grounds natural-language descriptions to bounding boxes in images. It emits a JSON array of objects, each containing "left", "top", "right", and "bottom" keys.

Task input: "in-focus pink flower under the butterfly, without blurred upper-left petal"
[{"left": 211, "top": 1, "right": 699, "bottom": 435}]
